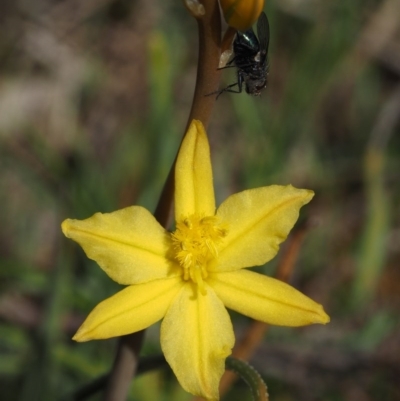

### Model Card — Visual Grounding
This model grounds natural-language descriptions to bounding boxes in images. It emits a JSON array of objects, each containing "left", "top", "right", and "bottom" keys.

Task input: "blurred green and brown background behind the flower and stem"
[{"left": 0, "top": 0, "right": 400, "bottom": 401}]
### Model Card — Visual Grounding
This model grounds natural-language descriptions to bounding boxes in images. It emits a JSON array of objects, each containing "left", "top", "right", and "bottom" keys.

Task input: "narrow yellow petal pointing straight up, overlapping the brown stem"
[{"left": 175, "top": 120, "right": 215, "bottom": 221}]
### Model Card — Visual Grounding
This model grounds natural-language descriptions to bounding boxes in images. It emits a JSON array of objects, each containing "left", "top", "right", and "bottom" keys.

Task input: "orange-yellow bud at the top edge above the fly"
[{"left": 220, "top": 0, "right": 264, "bottom": 31}]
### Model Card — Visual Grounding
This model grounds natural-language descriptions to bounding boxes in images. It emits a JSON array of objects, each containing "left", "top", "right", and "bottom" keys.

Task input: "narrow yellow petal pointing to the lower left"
[{"left": 73, "top": 277, "right": 182, "bottom": 341}]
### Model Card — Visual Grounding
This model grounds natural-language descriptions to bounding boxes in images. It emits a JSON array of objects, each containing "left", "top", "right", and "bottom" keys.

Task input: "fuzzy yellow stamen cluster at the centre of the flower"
[{"left": 172, "top": 215, "right": 227, "bottom": 295}]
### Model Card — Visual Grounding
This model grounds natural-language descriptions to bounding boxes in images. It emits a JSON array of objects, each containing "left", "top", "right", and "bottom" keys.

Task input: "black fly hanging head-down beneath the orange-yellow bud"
[{"left": 210, "top": 12, "right": 269, "bottom": 98}]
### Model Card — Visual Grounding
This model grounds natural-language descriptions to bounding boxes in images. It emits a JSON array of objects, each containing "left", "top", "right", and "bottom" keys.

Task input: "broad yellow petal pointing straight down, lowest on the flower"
[{"left": 161, "top": 283, "right": 235, "bottom": 400}]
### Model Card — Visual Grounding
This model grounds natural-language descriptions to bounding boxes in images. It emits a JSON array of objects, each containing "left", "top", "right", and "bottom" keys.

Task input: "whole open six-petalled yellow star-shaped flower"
[{"left": 62, "top": 121, "right": 329, "bottom": 400}]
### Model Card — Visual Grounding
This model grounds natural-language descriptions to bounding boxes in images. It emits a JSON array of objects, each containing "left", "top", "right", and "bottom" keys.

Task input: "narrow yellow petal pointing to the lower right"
[{"left": 208, "top": 270, "right": 329, "bottom": 326}]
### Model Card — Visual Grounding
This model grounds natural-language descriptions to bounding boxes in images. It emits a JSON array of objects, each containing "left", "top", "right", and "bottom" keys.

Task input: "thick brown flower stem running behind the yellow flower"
[{"left": 104, "top": 0, "right": 221, "bottom": 401}]
